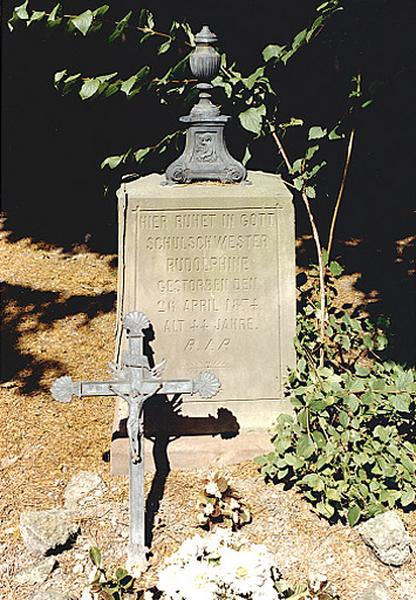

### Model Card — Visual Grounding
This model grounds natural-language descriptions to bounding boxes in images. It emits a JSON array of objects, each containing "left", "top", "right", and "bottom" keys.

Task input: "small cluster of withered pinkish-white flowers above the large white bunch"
[{"left": 197, "top": 473, "right": 251, "bottom": 531}]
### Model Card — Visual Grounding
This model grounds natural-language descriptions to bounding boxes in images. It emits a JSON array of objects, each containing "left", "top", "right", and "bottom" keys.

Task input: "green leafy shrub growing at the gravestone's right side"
[{"left": 256, "top": 262, "right": 416, "bottom": 525}]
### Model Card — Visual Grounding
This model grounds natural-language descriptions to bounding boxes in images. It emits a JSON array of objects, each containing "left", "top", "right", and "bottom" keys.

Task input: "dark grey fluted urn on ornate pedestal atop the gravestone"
[{"left": 166, "top": 25, "right": 247, "bottom": 184}]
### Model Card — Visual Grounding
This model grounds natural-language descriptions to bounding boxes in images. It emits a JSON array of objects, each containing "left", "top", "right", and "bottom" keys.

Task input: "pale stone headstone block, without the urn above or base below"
[{"left": 115, "top": 173, "right": 295, "bottom": 428}]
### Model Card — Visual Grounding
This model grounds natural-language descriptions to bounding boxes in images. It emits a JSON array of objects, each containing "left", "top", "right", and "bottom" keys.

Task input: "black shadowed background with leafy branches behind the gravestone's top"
[{"left": 3, "top": 0, "right": 414, "bottom": 366}]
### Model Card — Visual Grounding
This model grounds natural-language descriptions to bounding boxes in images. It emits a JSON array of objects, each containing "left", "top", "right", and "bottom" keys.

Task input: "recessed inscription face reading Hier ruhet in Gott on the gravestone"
[{"left": 135, "top": 207, "right": 281, "bottom": 400}]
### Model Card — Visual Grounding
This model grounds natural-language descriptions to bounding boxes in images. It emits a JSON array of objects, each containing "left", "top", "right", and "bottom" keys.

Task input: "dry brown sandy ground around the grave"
[{"left": 0, "top": 226, "right": 416, "bottom": 600}]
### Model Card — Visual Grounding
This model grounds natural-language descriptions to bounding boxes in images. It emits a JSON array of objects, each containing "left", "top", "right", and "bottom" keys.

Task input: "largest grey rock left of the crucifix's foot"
[{"left": 20, "top": 508, "right": 78, "bottom": 554}]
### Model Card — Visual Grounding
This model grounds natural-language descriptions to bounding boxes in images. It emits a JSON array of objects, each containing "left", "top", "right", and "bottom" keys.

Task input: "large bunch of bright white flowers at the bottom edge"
[{"left": 157, "top": 530, "right": 281, "bottom": 600}]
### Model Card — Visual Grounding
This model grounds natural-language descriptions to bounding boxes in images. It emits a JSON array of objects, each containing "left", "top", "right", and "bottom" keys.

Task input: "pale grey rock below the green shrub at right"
[{"left": 357, "top": 511, "right": 411, "bottom": 567}]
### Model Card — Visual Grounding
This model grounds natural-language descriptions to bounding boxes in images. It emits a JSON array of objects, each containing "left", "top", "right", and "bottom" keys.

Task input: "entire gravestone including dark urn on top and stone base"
[{"left": 112, "top": 26, "right": 295, "bottom": 473}]
